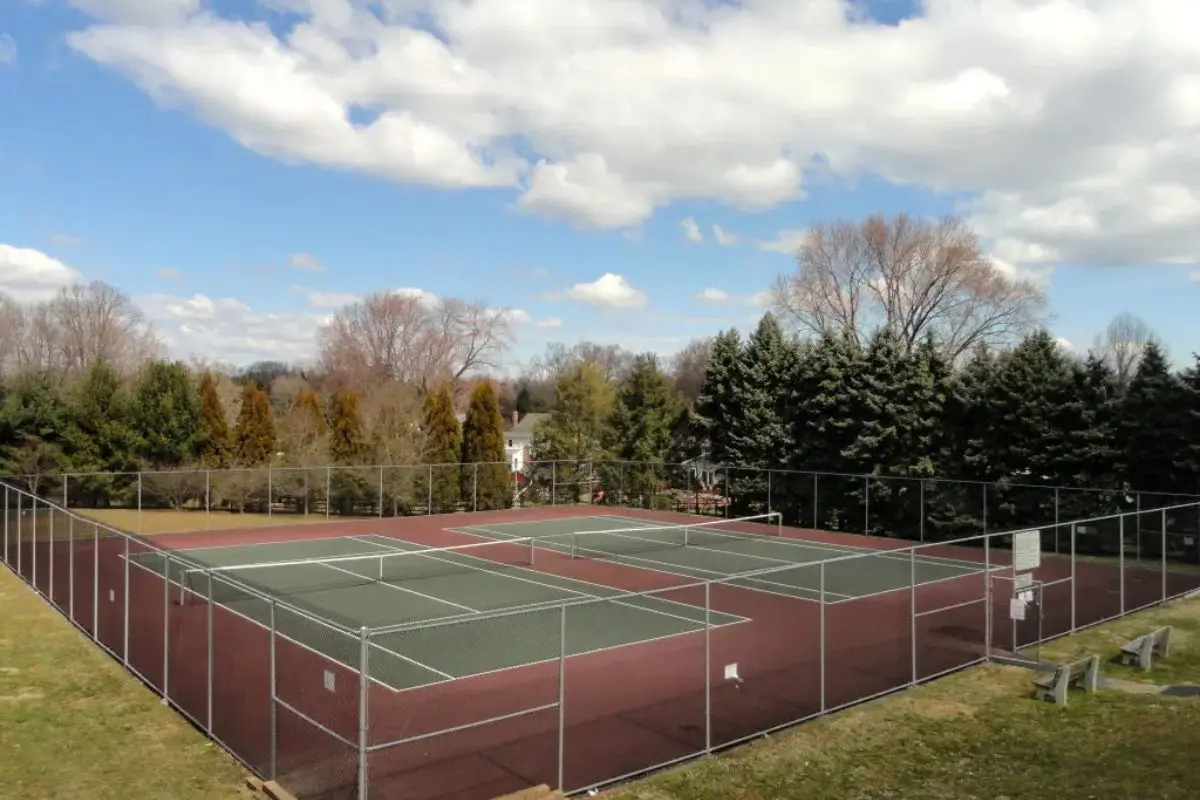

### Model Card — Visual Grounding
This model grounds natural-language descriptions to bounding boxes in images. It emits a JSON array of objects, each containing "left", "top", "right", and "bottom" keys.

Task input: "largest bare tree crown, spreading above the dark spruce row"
[{"left": 772, "top": 215, "right": 1045, "bottom": 359}]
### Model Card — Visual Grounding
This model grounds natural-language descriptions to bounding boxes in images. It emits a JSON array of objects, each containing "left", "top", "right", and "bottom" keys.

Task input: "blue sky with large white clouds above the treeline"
[{"left": 0, "top": 0, "right": 1200, "bottom": 362}]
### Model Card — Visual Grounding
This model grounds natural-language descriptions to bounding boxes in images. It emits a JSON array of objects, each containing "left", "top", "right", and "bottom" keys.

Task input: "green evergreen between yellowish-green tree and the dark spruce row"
[{"left": 604, "top": 354, "right": 682, "bottom": 509}]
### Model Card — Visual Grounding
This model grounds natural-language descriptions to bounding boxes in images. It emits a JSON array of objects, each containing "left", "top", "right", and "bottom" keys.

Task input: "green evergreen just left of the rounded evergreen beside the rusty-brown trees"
[{"left": 62, "top": 365, "right": 139, "bottom": 507}]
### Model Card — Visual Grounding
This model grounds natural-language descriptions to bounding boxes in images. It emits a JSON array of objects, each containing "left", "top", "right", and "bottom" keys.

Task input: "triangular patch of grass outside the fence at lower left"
[{"left": 0, "top": 567, "right": 251, "bottom": 800}]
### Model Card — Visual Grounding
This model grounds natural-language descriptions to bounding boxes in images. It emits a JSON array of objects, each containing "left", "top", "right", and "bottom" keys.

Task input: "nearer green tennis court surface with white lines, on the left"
[{"left": 131, "top": 527, "right": 746, "bottom": 691}]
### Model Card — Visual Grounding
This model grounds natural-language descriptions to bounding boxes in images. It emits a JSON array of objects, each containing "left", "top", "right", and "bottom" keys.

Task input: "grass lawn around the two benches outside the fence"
[{"left": 606, "top": 600, "right": 1200, "bottom": 800}]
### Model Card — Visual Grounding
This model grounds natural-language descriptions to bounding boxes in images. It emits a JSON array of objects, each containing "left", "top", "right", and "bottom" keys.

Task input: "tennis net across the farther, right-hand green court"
[{"left": 556, "top": 511, "right": 784, "bottom": 559}]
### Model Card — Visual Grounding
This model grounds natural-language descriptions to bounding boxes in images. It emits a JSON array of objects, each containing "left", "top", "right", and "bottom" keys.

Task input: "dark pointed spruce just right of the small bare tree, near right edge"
[{"left": 1117, "top": 342, "right": 1189, "bottom": 492}]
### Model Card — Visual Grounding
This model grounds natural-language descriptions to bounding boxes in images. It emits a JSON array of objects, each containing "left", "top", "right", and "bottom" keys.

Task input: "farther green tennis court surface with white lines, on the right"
[{"left": 452, "top": 515, "right": 993, "bottom": 603}]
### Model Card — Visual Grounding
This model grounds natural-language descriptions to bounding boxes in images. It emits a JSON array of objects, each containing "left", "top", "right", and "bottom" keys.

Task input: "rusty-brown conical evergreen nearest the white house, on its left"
[{"left": 462, "top": 380, "right": 512, "bottom": 511}]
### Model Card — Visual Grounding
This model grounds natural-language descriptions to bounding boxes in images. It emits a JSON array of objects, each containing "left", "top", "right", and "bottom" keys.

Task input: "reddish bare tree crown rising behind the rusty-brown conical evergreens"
[{"left": 319, "top": 291, "right": 512, "bottom": 390}]
